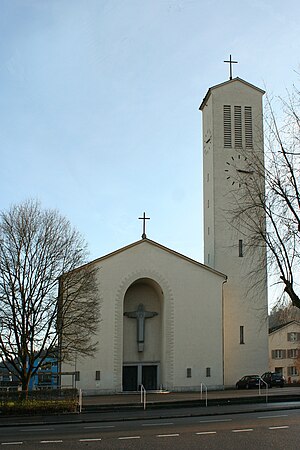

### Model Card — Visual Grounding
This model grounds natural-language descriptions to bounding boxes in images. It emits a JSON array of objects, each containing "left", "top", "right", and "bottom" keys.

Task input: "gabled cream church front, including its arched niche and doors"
[{"left": 62, "top": 238, "right": 226, "bottom": 393}]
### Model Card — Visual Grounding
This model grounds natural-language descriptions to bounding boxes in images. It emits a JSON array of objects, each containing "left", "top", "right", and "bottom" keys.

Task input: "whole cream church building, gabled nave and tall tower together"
[{"left": 62, "top": 78, "right": 268, "bottom": 394}]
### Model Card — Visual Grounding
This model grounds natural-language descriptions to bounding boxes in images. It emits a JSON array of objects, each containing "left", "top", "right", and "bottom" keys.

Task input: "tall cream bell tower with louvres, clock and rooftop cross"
[{"left": 200, "top": 75, "right": 268, "bottom": 386}]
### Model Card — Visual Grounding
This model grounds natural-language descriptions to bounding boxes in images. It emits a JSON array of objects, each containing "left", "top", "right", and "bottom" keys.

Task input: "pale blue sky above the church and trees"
[{"left": 0, "top": 0, "right": 300, "bottom": 276}]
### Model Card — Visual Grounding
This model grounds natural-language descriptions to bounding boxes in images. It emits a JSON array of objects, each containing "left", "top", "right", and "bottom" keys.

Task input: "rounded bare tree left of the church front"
[{"left": 0, "top": 201, "right": 100, "bottom": 391}]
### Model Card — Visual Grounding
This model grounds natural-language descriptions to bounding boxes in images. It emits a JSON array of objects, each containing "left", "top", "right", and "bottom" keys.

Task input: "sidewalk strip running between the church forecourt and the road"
[{"left": 0, "top": 388, "right": 300, "bottom": 427}]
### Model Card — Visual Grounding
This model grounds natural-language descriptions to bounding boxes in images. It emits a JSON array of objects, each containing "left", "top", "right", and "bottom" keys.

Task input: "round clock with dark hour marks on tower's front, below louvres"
[{"left": 225, "top": 153, "right": 254, "bottom": 188}]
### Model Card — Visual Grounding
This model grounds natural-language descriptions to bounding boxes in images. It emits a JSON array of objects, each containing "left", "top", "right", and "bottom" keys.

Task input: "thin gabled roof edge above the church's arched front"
[{"left": 75, "top": 238, "right": 227, "bottom": 280}]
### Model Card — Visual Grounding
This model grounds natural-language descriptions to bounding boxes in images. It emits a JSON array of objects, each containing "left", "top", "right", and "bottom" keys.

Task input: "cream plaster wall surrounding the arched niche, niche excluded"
[{"left": 64, "top": 240, "right": 224, "bottom": 392}]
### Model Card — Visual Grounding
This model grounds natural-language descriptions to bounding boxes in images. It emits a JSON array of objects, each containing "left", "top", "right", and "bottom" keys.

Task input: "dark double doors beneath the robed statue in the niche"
[{"left": 123, "top": 364, "right": 158, "bottom": 391}]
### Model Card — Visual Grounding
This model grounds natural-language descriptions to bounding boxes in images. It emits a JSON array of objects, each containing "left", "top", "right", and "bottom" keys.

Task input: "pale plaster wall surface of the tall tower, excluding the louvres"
[{"left": 203, "top": 80, "right": 268, "bottom": 386}]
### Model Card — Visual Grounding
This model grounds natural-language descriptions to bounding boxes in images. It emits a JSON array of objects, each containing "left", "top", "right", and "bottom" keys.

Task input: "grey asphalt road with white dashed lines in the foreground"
[{"left": 0, "top": 410, "right": 300, "bottom": 450}]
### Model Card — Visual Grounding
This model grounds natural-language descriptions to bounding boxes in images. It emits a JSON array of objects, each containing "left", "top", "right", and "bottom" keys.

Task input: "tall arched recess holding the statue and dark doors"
[{"left": 122, "top": 278, "right": 163, "bottom": 391}]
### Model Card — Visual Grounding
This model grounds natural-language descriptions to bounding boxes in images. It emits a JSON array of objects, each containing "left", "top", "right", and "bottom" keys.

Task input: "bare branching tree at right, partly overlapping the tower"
[{"left": 229, "top": 84, "right": 300, "bottom": 308}]
